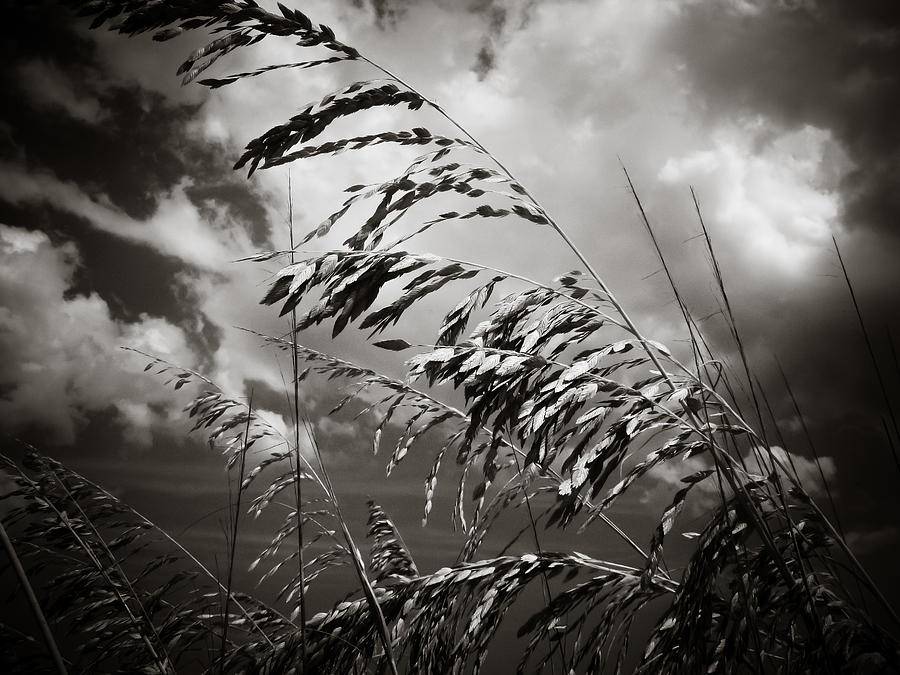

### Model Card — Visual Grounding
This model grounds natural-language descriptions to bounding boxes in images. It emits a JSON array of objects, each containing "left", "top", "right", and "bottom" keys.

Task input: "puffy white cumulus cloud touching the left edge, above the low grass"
[{"left": 0, "top": 225, "right": 193, "bottom": 444}]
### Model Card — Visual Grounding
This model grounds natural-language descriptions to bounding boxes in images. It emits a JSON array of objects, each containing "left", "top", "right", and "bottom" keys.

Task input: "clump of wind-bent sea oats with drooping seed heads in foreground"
[{"left": 3, "top": 0, "right": 900, "bottom": 673}]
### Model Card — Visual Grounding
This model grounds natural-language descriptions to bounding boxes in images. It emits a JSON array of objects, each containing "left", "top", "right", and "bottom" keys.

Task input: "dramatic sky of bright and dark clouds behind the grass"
[{"left": 0, "top": 0, "right": 900, "bottom": 612}]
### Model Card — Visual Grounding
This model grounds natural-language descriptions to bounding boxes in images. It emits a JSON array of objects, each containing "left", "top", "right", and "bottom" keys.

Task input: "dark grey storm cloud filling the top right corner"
[{"left": 670, "top": 0, "right": 900, "bottom": 238}]
